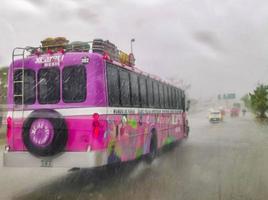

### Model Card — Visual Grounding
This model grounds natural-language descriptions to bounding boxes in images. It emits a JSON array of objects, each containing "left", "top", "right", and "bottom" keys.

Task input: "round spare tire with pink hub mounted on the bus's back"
[{"left": 22, "top": 109, "right": 68, "bottom": 157}]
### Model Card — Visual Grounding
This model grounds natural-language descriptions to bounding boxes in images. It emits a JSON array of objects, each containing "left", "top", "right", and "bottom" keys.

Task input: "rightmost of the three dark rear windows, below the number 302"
[{"left": 62, "top": 65, "right": 87, "bottom": 103}]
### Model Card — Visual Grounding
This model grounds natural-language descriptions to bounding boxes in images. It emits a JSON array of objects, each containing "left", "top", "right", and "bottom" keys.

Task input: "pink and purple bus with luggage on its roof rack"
[{"left": 4, "top": 38, "right": 189, "bottom": 168}]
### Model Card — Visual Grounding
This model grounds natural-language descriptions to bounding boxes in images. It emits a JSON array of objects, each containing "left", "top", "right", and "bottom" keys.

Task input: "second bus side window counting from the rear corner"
[{"left": 119, "top": 70, "right": 130, "bottom": 107}]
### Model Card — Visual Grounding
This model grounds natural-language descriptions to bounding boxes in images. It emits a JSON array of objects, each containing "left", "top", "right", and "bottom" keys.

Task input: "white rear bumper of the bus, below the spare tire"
[{"left": 3, "top": 151, "right": 108, "bottom": 168}]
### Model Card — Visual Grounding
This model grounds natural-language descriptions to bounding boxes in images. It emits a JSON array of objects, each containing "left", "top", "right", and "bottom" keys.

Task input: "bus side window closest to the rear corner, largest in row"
[{"left": 107, "top": 63, "right": 120, "bottom": 106}]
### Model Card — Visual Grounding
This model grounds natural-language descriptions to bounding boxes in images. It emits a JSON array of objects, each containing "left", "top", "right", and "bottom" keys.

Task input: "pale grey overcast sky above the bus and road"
[{"left": 0, "top": 0, "right": 268, "bottom": 98}]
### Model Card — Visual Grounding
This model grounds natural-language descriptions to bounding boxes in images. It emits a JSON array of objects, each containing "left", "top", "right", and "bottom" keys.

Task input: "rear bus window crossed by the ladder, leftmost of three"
[{"left": 14, "top": 69, "right": 36, "bottom": 104}]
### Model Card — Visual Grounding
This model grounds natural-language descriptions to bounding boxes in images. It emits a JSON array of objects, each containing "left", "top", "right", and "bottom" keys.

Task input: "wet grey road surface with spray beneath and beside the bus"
[{"left": 0, "top": 113, "right": 268, "bottom": 200}]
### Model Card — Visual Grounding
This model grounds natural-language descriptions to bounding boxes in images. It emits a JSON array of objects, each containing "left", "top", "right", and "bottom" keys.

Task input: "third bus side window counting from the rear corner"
[{"left": 130, "top": 73, "right": 140, "bottom": 107}]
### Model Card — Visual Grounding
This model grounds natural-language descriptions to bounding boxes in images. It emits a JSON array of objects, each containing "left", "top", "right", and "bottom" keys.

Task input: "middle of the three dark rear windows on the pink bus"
[{"left": 38, "top": 68, "right": 60, "bottom": 104}]
